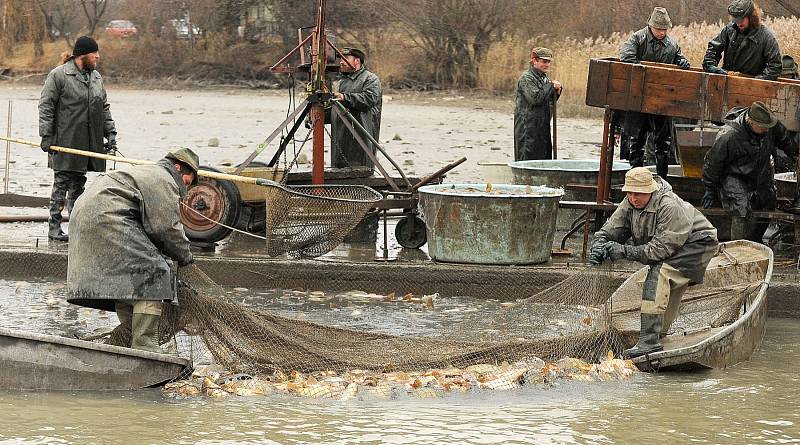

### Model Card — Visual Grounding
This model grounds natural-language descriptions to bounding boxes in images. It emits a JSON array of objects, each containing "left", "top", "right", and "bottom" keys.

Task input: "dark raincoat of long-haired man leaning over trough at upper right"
[{"left": 703, "top": 22, "right": 783, "bottom": 80}]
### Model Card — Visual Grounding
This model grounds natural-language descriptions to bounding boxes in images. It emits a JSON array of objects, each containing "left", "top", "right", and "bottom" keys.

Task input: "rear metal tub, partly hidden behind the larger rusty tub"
[{"left": 508, "top": 159, "right": 631, "bottom": 230}]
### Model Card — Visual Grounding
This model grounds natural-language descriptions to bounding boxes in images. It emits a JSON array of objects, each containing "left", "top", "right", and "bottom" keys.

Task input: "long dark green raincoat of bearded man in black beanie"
[{"left": 39, "top": 59, "right": 117, "bottom": 173}]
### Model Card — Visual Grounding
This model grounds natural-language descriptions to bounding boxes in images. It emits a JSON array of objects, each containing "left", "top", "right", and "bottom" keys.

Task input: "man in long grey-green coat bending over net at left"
[{"left": 67, "top": 148, "right": 200, "bottom": 352}]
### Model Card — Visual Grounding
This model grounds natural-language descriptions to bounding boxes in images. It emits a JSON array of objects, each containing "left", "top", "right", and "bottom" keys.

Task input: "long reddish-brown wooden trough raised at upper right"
[{"left": 586, "top": 59, "right": 800, "bottom": 131}]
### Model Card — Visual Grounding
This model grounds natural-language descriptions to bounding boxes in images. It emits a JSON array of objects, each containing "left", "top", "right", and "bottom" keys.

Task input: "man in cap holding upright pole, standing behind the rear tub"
[{"left": 514, "top": 48, "right": 563, "bottom": 161}]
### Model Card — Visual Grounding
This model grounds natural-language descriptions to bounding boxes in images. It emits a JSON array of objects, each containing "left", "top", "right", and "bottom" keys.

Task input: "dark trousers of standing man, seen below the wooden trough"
[{"left": 624, "top": 111, "right": 672, "bottom": 179}]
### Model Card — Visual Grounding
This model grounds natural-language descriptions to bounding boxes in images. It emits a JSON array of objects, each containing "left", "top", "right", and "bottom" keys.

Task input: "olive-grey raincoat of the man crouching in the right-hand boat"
[{"left": 592, "top": 177, "right": 719, "bottom": 283}]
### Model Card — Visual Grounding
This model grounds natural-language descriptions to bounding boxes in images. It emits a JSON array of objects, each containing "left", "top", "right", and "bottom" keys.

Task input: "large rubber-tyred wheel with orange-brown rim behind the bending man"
[{"left": 181, "top": 166, "right": 242, "bottom": 243}]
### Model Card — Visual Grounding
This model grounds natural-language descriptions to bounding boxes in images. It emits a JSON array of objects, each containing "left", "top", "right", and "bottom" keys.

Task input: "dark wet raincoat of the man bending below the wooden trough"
[{"left": 703, "top": 107, "right": 797, "bottom": 217}]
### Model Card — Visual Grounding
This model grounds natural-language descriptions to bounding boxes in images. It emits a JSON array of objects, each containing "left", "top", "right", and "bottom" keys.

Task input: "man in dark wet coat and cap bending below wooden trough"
[{"left": 703, "top": 102, "right": 797, "bottom": 242}]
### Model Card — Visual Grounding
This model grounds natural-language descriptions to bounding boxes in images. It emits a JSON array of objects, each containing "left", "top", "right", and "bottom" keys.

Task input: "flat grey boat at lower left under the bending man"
[{"left": 0, "top": 329, "right": 192, "bottom": 391}]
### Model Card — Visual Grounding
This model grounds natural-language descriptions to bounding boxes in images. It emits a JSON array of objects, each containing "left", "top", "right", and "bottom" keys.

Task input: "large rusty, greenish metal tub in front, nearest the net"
[{"left": 419, "top": 184, "right": 564, "bottom": 264}]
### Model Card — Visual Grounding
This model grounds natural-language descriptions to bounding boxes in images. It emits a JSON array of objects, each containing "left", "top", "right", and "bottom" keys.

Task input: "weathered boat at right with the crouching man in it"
[{"left": 611, "top": 241, "right": 773, "bottom": 370}]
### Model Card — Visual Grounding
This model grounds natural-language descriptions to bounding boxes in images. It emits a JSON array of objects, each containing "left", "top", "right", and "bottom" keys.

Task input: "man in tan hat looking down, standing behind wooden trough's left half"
[{"left": 619, "top": 7, "right": 690, "bottom": 179}]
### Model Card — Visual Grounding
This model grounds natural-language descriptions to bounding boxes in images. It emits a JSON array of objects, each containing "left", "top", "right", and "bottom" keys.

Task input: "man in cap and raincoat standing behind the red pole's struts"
[{"left": 331, "top": 48, "right": 383, "bottom": 170}]
